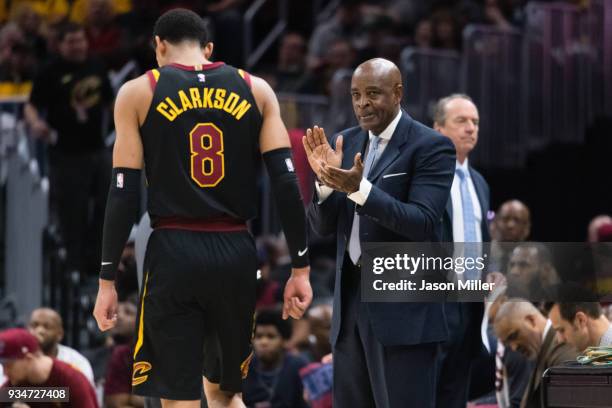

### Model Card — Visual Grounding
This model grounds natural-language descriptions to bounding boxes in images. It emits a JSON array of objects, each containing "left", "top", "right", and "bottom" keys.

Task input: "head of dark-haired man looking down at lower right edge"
[{"left": 550, "top": 302, "right": 612, "bottom": 352}]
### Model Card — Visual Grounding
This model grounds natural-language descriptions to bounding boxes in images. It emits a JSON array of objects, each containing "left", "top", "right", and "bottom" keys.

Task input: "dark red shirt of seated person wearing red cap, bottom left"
[{"left": 0, "top": 359, "right": 98, "bottom": 408}]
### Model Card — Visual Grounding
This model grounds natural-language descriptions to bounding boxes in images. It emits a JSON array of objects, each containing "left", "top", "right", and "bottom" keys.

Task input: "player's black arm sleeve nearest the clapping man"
[{"left": 263, "top": 147, "right": 309, "bottom": 268}]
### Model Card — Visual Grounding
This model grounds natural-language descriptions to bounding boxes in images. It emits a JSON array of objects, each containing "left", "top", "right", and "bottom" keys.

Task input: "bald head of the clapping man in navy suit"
[{"left": 351, "top": 58, "right": 403, "bottom": 135}]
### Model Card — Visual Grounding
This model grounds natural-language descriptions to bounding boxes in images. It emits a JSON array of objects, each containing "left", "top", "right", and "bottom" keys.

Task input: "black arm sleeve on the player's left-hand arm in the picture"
[{"left": 100, "top": 167, "right": 142, "bottom": 280}]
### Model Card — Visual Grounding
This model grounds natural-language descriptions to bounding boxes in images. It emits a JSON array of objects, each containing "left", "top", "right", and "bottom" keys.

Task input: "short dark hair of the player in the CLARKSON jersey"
[{"left": 153, "top": 8, "right": 208, "bottom": 47}]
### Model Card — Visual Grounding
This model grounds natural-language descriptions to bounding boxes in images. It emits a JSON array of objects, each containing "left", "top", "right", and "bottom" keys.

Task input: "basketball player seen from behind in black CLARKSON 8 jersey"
[{"left": 94, "top": 9, "right": 312, "bottom": 407}]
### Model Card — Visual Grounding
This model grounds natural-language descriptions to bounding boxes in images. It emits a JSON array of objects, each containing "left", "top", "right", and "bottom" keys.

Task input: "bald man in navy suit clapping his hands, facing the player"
[{"left": 304, "top": 58, "right": 455, "bottom": 408}]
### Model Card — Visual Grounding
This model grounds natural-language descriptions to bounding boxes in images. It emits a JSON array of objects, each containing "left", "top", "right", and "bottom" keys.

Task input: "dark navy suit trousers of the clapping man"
[{"left": 333, "top": 254, "right": 439, "bottom": 408}]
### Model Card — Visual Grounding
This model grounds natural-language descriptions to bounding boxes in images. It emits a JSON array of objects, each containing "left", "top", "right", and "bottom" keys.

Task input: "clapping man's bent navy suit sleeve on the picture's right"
[{"left": 357, "top": 135, "right": 455, "bottom": 241}]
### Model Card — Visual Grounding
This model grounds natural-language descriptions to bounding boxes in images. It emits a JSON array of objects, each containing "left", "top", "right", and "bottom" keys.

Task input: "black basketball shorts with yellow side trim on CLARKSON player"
[{"left": 132, "top": 229, "right": 257, "bottom": 400}]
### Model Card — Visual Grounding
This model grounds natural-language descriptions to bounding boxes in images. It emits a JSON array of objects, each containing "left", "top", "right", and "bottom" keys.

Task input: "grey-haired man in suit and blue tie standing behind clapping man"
[{"left": 434, "top": 94, "right": 495, "bottom": 408}]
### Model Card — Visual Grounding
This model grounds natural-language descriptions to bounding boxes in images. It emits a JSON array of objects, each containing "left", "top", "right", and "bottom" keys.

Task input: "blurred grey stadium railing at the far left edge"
[{"left": 0, "top": 101, "right": 49, "bottom": 326}]
